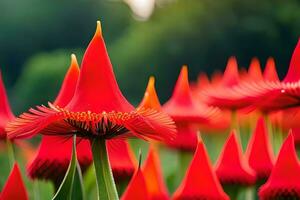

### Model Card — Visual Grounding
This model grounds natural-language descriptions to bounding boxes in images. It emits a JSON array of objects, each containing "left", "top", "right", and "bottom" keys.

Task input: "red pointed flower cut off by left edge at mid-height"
[{"left": 0, "top": 73, "right": 14, "bottom": 139}]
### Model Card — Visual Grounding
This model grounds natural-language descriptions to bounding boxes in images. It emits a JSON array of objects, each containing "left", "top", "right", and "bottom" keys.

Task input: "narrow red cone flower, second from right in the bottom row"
[{"left": 246, "top": 118, "right": 274, "bottom": 179}]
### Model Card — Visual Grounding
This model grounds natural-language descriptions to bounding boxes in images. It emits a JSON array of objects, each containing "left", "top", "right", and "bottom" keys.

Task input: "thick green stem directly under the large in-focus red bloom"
[{"left": 92, "top": 139, "right": 119, "bottom": 200}]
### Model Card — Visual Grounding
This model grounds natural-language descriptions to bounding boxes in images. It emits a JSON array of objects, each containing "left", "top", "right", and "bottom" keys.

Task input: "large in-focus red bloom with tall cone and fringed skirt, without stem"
[{"left": 7, "top": 22, "right": 175, "bottom": 140}]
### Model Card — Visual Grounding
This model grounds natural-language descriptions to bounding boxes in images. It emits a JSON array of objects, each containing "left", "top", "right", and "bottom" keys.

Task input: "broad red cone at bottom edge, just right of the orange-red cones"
[{"left": 173, "top": 142, "right": 229, "bottom": 200}]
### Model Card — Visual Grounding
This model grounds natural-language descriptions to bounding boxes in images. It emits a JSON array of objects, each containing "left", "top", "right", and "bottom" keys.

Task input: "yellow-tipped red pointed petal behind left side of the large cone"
[{"left": 53, "top": 54, "right": 79, "bottom": 107}]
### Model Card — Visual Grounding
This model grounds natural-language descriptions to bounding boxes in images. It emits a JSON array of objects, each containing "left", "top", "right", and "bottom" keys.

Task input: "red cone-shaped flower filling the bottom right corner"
[{"left": 259, "top": 132, "right": 300, "bottom": 200}]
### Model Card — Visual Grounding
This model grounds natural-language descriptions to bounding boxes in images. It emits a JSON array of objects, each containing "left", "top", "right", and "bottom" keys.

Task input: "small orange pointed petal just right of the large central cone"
[{"left": 138, "top": 76, "right": 161, "bottom": 110}]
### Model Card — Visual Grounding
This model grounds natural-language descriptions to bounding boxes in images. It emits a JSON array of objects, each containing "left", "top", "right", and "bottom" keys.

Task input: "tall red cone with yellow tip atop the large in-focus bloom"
[{"left": 67, "top": 21, "right": 133, "bottom": 113}]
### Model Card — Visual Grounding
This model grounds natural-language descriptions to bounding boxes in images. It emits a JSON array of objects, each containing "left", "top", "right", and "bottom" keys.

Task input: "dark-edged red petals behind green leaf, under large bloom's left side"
[{"left": 27, "top": 136, "right": 92, "bottom": 184}]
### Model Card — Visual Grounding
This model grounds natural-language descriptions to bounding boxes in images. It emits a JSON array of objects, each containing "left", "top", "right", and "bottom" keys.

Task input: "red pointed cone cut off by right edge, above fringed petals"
[{"left": 283, "top": 39, "right": 300, "bottom": 83}]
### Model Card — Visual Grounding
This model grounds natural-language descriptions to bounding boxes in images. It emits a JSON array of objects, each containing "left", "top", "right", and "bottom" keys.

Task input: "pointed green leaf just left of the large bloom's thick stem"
[{"left": 52, "top": 135, "right": 84, "bottom": 200}]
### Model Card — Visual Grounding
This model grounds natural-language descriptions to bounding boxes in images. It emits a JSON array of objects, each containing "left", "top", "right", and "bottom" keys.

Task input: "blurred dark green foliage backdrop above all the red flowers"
[{"left": 0, "top": 0, "right": 300, "bottom": 114}]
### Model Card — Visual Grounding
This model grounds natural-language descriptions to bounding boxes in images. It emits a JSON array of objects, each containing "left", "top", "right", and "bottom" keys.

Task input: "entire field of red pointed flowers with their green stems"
[{"left": 0, "top": 22, "right": 300, "bottom": 200}]
